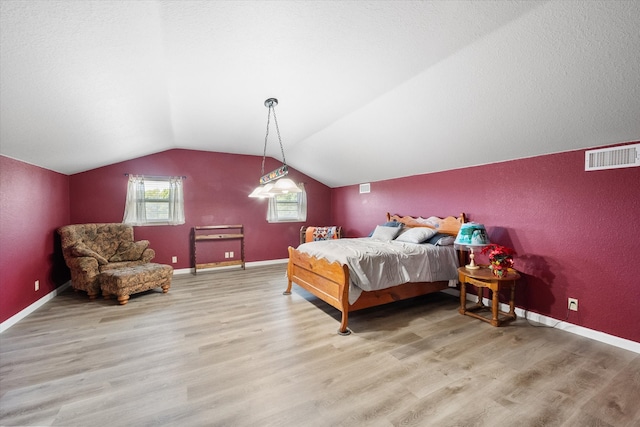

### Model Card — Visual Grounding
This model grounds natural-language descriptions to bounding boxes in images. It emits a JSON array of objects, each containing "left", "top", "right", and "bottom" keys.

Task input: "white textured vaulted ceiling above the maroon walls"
[{"left": 0, "top": 0, "right": 640, "bottom": 187}]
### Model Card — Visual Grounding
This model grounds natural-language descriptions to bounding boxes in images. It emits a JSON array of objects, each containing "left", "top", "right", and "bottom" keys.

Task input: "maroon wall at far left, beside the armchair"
[{"left": 0, "top": 156, "right": 69, "bottom": 322}]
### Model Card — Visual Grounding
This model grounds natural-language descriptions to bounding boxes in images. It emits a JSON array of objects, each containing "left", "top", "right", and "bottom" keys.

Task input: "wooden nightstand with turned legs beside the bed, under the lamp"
[{"left": 458, "top": 266, "right": 520, "bottom": 326}]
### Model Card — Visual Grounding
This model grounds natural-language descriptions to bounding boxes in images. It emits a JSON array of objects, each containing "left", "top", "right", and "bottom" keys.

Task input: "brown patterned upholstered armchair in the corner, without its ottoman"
[{"left": 58, "top": 223, "right": 156, "bottom": 299}]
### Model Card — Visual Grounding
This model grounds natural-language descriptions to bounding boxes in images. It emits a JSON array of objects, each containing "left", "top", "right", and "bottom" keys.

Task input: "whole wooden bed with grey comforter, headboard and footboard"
[{"left": 284, "top": 214, "right": 465, "bottom": 335}]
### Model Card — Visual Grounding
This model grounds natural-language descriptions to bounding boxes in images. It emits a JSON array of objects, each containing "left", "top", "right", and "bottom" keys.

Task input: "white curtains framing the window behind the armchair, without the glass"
[{"left": 122, "top": 175, "right": 185, "bottom": 225}]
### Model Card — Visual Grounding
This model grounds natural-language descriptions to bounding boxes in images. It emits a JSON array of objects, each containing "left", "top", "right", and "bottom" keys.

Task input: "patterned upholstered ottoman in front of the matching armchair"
[{"left": 100, "top": 262, "right": 173, "bottom": 305}]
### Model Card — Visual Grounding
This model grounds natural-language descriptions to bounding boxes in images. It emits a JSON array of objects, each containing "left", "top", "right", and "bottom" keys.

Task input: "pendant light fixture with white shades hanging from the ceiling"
[{"left": 249, "top": 98, "right": 302, "bottom": 198}]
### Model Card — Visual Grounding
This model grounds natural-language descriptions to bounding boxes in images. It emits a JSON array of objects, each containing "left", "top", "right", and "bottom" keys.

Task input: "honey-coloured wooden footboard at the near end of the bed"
[{"left": 284, "top": 246, "right": 351, "bottom": 335}]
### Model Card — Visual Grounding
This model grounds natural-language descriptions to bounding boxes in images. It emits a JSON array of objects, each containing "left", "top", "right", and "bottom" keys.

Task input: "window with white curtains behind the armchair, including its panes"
[{"left": 122, "top": 175, "right": 185, "bottom": 225}]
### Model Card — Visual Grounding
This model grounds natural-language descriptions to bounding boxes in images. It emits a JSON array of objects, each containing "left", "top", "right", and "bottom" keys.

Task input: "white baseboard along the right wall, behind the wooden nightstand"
[{"left": 442, "top": 289, "right": 640, "bottom": 354}]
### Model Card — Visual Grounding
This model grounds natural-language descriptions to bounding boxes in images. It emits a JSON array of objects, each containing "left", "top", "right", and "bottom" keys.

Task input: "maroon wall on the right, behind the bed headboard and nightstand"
[{"left": 332, "top": 144, "right": 640, "bottom": 342}]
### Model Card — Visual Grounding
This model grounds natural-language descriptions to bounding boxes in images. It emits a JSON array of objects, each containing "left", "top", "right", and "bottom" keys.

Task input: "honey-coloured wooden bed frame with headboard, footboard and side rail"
[{"left": 283, "top": 213, "right": 466, "bottom": 335}]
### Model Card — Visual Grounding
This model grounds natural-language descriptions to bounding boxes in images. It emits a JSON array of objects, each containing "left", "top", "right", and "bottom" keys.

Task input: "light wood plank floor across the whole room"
[{"left": 0, "top": 264, "right": 640, "bottom": 427}]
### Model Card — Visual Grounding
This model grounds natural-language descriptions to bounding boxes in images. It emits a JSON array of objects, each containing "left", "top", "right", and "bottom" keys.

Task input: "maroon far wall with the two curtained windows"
[{"left": 70, "top": 149, "right": 331, "bottom": 268}]
